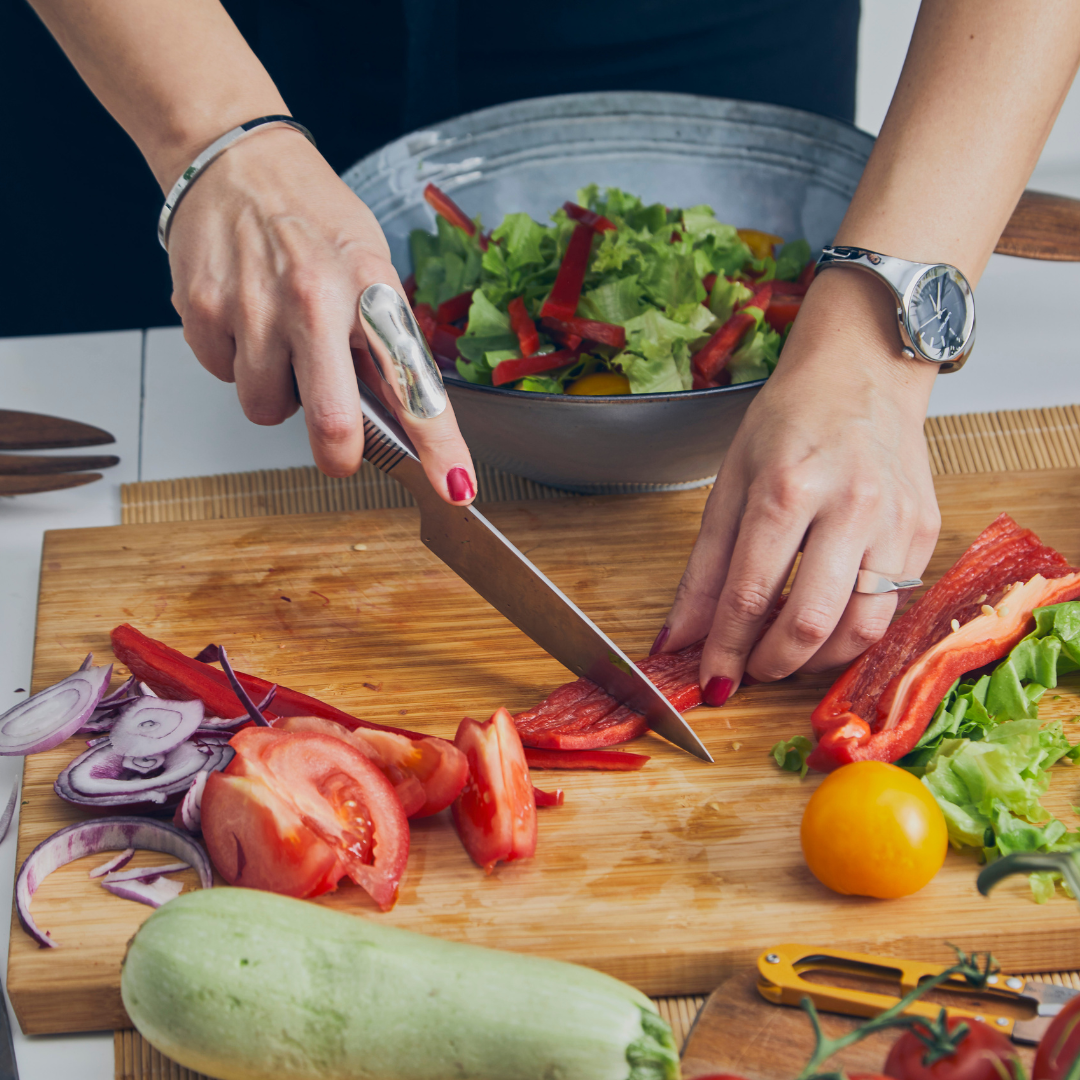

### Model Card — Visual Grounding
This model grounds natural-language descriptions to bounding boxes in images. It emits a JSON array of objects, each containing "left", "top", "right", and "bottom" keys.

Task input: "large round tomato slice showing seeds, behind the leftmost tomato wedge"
[{"left": 203, "top": 727, "right": 409, "bottom": 912}]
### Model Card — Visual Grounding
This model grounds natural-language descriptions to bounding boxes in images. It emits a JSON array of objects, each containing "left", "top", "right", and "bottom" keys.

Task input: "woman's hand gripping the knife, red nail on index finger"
[{"left": 168, "top": 130, "right": 476, "bottom": 503}]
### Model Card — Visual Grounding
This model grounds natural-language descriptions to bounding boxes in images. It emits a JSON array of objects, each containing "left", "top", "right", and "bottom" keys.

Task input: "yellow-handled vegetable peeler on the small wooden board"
[{"left": 757, "top": 945, "right": 1080, "bottom": 1045}]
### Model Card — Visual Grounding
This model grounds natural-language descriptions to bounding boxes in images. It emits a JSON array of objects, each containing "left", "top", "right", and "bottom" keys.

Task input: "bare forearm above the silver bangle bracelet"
[{"left": 30, "top": 0, "right": 288, "bottom": 190}]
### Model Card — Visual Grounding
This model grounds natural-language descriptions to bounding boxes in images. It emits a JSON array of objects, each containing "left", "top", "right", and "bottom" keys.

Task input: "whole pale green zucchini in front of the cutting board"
[{"left": 120, "top": 889, "right": 679, "bottom": 1080}]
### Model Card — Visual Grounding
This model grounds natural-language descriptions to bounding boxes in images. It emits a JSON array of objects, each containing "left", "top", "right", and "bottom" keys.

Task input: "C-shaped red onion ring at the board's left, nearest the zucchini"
[{"left": 15, "top": 818, "right": 214, "bottom": 948}]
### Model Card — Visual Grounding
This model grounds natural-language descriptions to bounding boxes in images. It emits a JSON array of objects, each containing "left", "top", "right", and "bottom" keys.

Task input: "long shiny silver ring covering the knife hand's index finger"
[{"left": 360, "top": 282, "right": 447, "bottom": 420}]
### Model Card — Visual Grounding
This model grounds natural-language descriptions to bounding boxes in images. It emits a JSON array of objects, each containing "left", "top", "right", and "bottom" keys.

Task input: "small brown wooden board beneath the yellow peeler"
[{"left": 683, "top": 971, "right": 1035, "bottom": 1080}]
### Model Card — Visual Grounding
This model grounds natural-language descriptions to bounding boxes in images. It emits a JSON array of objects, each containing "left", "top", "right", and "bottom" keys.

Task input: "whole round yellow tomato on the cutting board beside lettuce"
[{"left": 800, "top": 761, "right": 948, "bottom": 899}]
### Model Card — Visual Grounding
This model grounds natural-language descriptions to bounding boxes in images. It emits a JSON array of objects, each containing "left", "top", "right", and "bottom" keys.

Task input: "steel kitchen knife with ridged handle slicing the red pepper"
[{"left": 359, "top": 382, "right": 713, "bottom": 761}]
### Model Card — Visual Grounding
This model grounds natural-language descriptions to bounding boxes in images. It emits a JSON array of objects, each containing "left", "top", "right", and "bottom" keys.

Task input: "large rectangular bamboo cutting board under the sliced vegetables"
[{"left": 8, "top": 471, "right": 1080, "bottom": 1032}]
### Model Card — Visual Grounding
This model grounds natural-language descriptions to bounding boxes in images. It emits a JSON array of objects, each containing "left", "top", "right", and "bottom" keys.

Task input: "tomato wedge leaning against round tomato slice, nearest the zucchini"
[{"left": 202, "top": 772, "right": 345, "bottom": 899}]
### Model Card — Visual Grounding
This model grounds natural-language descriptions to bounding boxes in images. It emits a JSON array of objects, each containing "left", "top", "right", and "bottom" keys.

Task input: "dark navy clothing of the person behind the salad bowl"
[{"left": 0, "top": 0, "right": 859, "bottom": 337}]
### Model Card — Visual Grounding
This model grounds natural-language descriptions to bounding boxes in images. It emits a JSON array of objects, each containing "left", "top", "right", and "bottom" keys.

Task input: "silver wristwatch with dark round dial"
[{"left": 818, "top": 247, "right": 975, "bottom": 373}]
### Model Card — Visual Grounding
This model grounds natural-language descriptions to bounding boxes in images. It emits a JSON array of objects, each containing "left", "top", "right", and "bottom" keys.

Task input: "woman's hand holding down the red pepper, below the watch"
[{"left": 653, "top": 269, "right": 941, "bottom": 705}]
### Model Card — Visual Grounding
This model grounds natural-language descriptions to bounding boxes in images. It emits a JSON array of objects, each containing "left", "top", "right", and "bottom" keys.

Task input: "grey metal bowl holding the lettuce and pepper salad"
[{"left": 343, "top": 93, "right": 874, "bottom": 494}]
